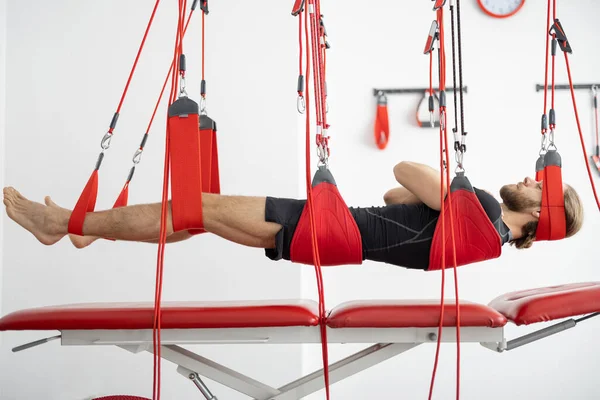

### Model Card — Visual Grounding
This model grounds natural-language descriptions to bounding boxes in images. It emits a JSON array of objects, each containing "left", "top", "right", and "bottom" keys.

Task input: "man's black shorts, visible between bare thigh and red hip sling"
[{"left": 265, "top": 197, "right": 306, "bottom": 261}]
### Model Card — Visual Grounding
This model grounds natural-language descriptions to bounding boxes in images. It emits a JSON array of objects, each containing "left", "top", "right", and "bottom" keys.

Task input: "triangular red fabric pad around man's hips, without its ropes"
[{"left": 290, "top": 178, "right": 362, "bottom": 266}]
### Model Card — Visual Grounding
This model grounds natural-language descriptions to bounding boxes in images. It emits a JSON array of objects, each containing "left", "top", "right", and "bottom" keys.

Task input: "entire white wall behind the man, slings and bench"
[{"left": 0, "top": 0, "right": 600, "bottom": 400}]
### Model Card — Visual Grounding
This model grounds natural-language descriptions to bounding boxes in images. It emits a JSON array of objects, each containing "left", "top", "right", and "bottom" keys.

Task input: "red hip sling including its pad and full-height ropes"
[{"left": 290, "top": 0, "right": 362, "bottom": 399}]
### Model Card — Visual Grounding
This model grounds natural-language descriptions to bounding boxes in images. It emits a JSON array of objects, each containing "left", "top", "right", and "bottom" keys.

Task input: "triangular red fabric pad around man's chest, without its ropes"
[{"left": 427, "top": 183, "right": 502, "bottom": 271}]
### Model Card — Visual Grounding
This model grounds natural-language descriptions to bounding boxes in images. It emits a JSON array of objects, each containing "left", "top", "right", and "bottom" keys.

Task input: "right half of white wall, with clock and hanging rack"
[{"left": 303, "top": 0, "right": 600, "bottom": 400}]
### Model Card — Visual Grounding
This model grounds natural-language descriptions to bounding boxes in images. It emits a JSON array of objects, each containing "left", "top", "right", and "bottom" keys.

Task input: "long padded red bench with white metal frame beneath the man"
[{"left": 0, "top": 282, "right": 600, "bottom": 400}]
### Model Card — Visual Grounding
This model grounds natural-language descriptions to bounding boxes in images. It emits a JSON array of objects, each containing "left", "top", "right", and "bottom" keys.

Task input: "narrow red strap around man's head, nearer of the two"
[{"left": 536, "top": 150, "right": 567, "bottom": 241}]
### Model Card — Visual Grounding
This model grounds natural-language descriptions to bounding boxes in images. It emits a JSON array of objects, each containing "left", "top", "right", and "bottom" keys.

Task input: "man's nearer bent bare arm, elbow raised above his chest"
[{"left": 394, "top": 161, "right": 447, "bottom": 211}]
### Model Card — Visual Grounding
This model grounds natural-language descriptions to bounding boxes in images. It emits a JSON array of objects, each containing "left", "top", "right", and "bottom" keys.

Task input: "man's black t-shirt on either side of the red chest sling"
[{"left": 350, "top": 188, "right": 511, "bottom": 269}]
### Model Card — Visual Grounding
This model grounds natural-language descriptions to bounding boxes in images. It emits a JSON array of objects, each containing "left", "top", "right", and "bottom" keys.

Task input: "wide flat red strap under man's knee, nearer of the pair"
[{"left": 168, "top": 97, "right": 204, "bottom": 232}]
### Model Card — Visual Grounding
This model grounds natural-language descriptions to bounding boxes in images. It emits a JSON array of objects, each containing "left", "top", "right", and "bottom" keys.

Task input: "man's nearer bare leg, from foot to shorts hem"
[{"left": 4, "top": 188, "right": 281, "bottom": 248}]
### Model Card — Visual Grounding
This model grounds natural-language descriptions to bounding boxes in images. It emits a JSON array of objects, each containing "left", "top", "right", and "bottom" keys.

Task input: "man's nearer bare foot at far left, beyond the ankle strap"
[{"left": 4, "top": 187, "right": 70, "bottom": 245}]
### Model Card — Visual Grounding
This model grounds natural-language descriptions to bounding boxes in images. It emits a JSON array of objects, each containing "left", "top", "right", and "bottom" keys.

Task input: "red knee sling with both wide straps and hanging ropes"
[{"left": 153, "top": 0, "right": 220, "bottom": 399}]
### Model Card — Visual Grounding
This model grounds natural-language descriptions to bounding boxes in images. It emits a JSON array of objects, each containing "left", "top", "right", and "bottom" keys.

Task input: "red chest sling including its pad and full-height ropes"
[{"left": 424, "top": 0, "right": 501, "bottom": 399}]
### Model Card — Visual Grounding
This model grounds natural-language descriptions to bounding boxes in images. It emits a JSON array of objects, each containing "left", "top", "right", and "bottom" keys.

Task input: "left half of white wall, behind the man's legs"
[{"left": 0, "top": 0, "right": 301, "bottom": 399}]
